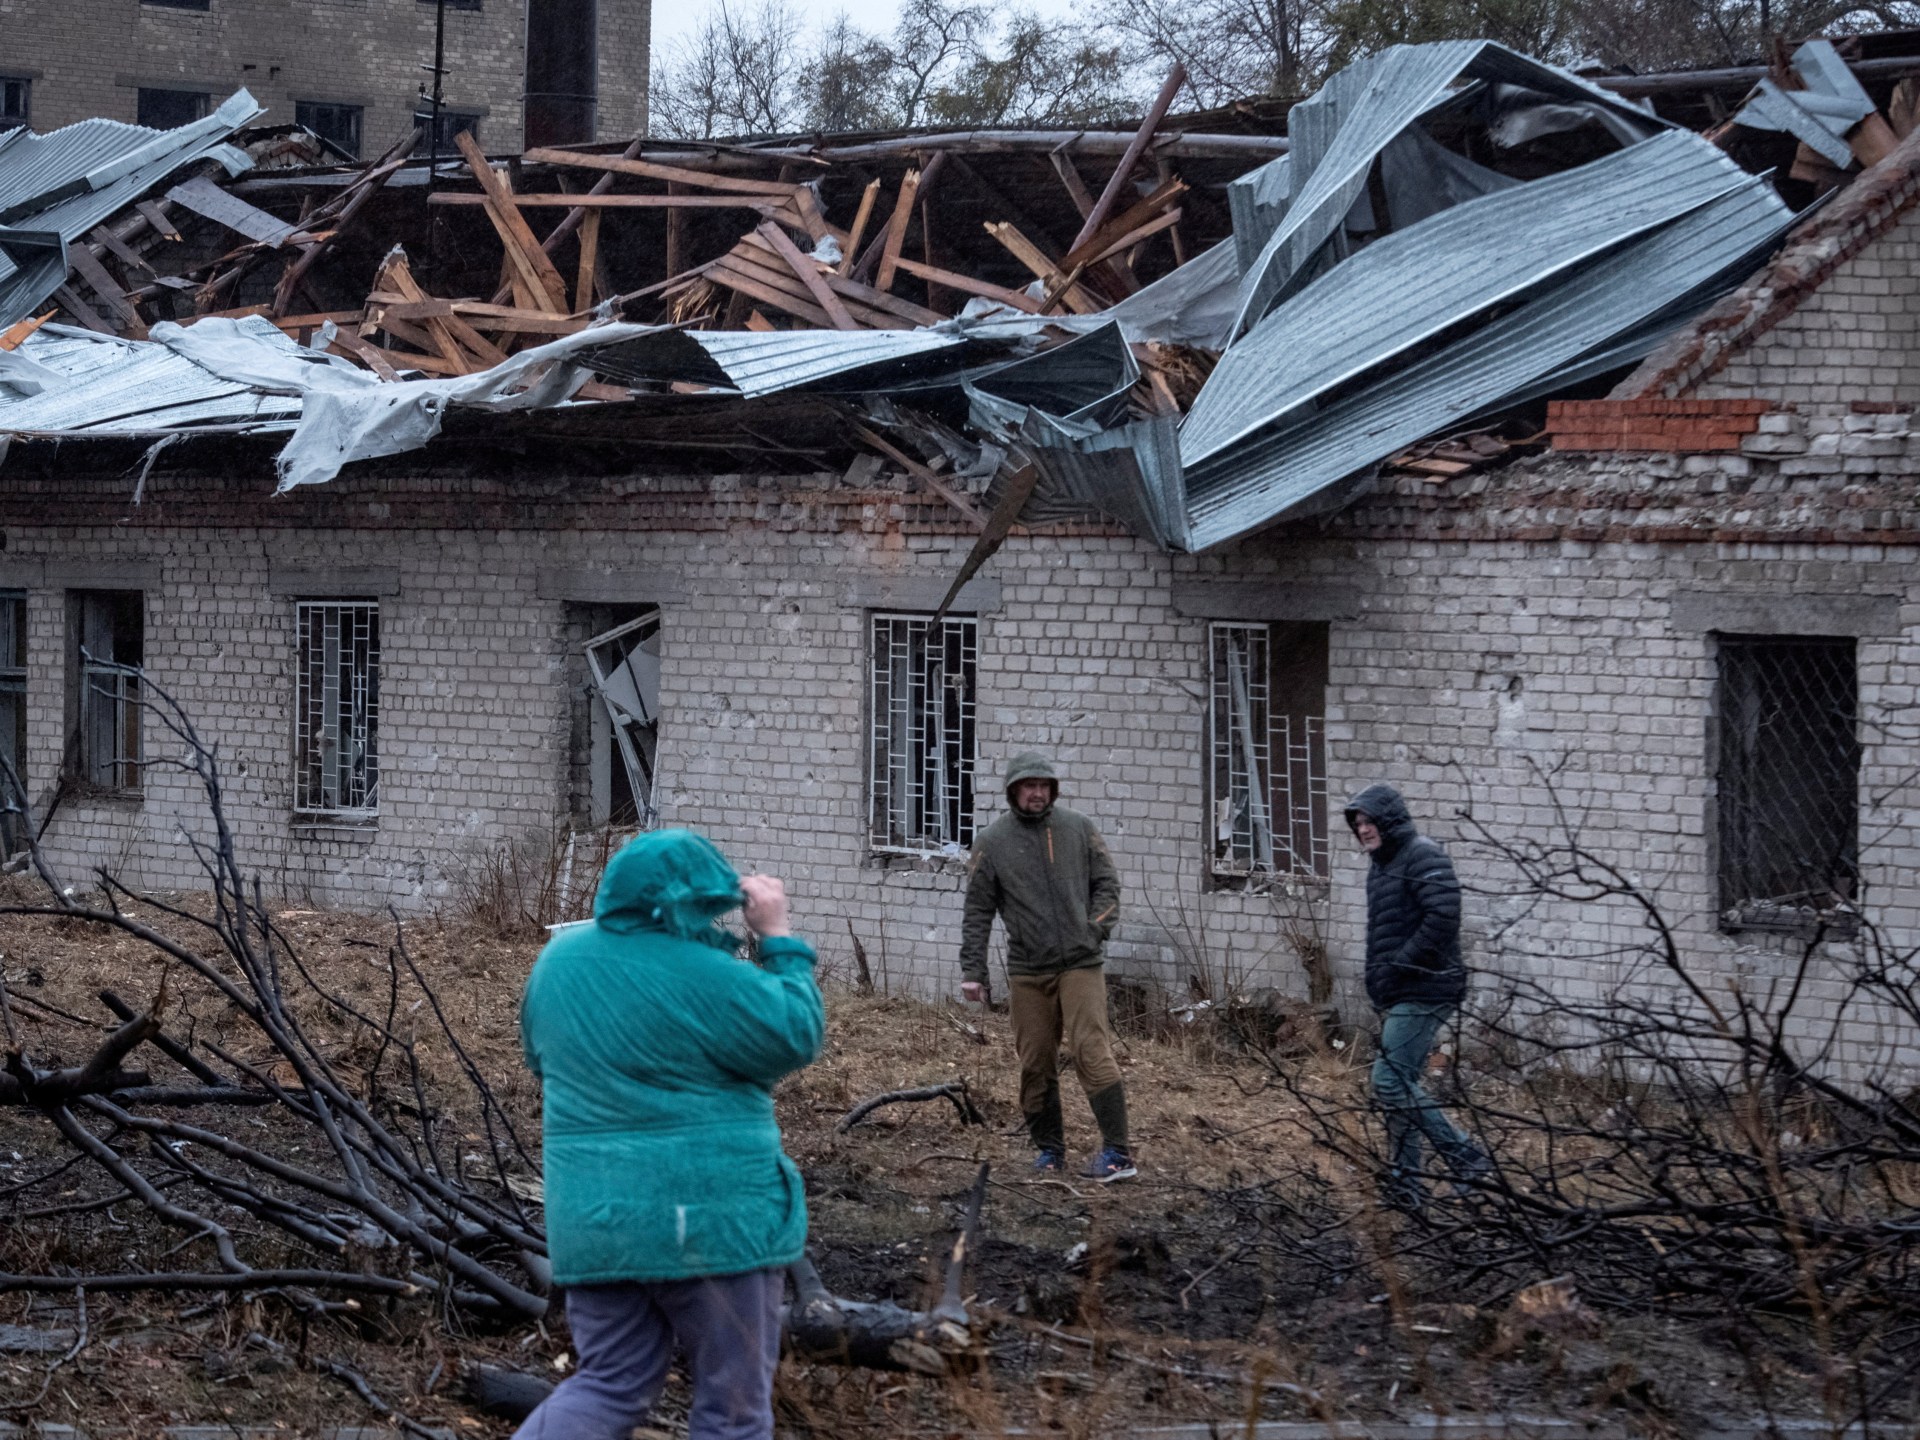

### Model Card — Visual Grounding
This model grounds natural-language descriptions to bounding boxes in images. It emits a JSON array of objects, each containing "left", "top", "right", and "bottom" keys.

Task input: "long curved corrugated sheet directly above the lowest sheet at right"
[{"left": 1181, "top": 131, "right": 1751, "bottom": 465}]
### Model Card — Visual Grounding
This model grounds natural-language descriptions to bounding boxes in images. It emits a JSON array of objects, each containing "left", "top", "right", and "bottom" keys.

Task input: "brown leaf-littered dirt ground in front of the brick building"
[{"left": 0, "top": 906, "right": 1896, "bottom": 1436}]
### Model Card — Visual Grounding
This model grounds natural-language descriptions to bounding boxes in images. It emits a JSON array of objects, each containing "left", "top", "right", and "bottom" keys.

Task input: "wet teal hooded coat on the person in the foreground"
[{"left": 520, "top": 829, "right": 826, "bottom": 1284}]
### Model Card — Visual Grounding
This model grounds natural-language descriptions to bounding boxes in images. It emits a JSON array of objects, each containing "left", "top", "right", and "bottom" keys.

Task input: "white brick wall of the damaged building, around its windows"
[{"left": 6, "top": 506, "right": 1920, "bottom": 1082}]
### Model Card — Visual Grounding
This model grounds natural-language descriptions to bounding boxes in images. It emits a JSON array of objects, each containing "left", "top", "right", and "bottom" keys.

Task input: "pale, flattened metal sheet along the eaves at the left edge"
[{"left": 0, "top": 326, "right": 300, "bottom": 436}]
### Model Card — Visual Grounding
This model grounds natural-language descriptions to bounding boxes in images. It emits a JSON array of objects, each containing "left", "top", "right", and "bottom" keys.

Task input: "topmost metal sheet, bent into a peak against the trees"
[{"left": 1233, "top": 40, "right": 1667, "bottom": 334}]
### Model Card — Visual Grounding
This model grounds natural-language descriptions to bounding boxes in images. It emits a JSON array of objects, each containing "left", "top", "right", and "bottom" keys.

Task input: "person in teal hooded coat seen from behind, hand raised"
[{"left": 516, "top": 829, "right": 826, "bottom": 1440}]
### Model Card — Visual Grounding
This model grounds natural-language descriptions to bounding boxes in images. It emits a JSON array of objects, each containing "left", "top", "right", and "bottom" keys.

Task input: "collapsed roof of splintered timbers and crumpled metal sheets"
[{"left": 0, "top": 40, "right": 1920, "bottom": 551}]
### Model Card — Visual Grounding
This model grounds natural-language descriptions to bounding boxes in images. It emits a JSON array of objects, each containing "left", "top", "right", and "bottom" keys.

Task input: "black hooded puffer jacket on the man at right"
[{"left": 1346, "top": 785, "right": 1467, "bottom": 1010}]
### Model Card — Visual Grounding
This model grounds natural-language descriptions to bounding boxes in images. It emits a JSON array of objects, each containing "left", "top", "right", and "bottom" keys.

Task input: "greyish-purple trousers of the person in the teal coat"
[{"left": 513, "top": 1269, "right": 785, "bottom": 1440}]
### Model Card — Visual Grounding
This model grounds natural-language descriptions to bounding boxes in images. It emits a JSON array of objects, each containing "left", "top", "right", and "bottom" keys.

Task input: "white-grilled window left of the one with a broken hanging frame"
[{"left": 294, "top": 601, "right": 380, "bottom": 820}]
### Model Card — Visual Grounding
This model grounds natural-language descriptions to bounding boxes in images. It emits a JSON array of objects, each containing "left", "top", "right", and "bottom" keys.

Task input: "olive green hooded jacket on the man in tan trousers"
[{"left": 960, "top": 755, "right": 1119, "bottom": 983}]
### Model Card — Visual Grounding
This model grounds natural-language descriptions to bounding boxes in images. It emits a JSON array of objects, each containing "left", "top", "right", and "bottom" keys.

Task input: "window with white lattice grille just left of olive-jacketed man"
[{"left": 868, "top": 614, "right": 979, "bottom": 854}]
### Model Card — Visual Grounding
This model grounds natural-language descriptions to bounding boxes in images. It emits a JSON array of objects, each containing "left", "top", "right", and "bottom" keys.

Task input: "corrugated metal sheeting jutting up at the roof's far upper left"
[{"left": 0, "top": 90, "right": 265, "bottom": 326}]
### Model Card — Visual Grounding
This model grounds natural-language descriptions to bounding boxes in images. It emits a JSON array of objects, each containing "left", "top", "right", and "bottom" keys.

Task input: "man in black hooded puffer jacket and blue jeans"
[{"left": 1346, "top": 785, "right": 1488, "bottom": 1210}]
